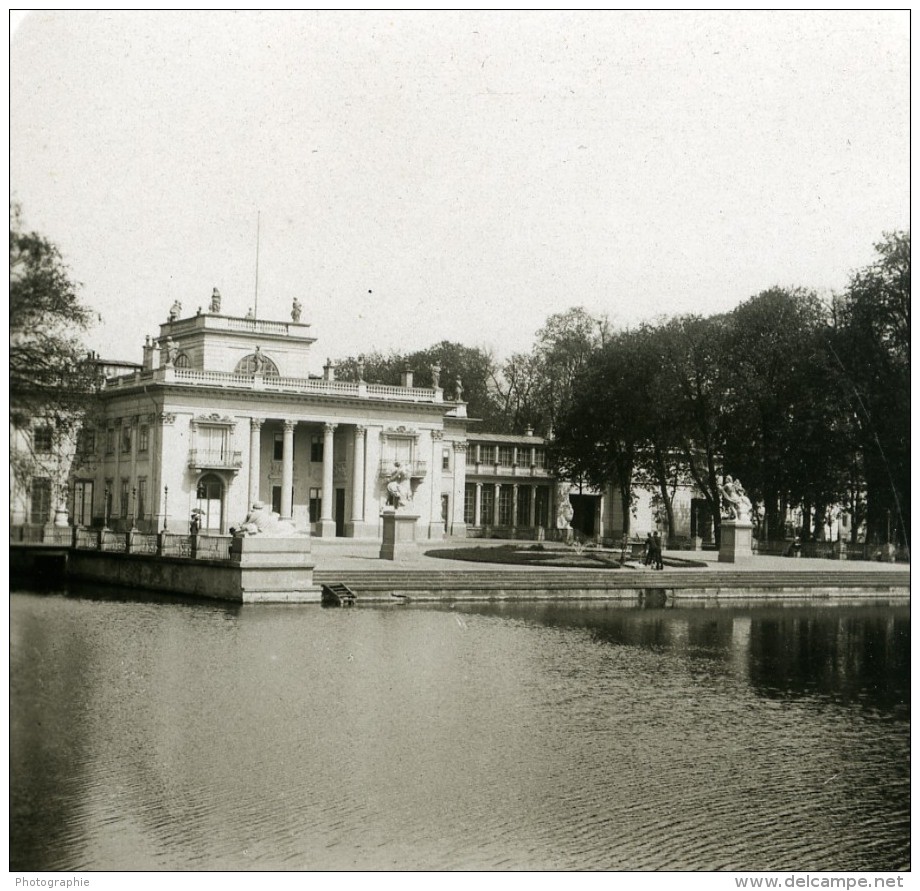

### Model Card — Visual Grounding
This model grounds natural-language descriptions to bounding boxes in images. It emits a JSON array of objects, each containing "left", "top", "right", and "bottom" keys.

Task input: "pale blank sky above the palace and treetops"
[{"left": 10, "top": 11, "right": 910, "bottom": 361}]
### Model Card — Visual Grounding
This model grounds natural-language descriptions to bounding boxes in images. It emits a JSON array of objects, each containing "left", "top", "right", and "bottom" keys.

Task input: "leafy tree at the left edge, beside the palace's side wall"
[{"left": 10, "top": 203, "right": 94, "bottom": 506}]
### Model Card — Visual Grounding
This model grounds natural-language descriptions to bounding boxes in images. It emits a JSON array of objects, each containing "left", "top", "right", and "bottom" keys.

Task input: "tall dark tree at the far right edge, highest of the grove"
[{"left": 829, "top": 232, "right": 910, "bottom": 544}]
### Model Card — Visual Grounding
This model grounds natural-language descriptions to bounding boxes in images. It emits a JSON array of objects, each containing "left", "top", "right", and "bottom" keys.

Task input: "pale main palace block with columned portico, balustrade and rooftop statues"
[{"left": 71, "top": 304, "right": 467, "bottom": 538}]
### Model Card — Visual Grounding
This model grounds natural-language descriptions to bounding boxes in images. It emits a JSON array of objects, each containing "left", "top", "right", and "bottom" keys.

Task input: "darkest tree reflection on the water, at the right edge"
[{"left": 749, "top": 607, "right": 910, "bottom": 719}]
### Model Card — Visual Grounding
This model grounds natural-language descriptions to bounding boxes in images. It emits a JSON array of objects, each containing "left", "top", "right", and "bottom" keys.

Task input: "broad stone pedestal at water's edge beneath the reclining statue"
[{"left": 230, "top": 535, "right": 322, "bottom": 603}]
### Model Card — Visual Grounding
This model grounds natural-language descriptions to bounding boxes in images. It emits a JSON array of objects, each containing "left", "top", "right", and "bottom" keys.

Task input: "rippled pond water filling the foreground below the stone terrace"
[{"left": 11, "top": 593, "right": 909, "bottom": 870}]
